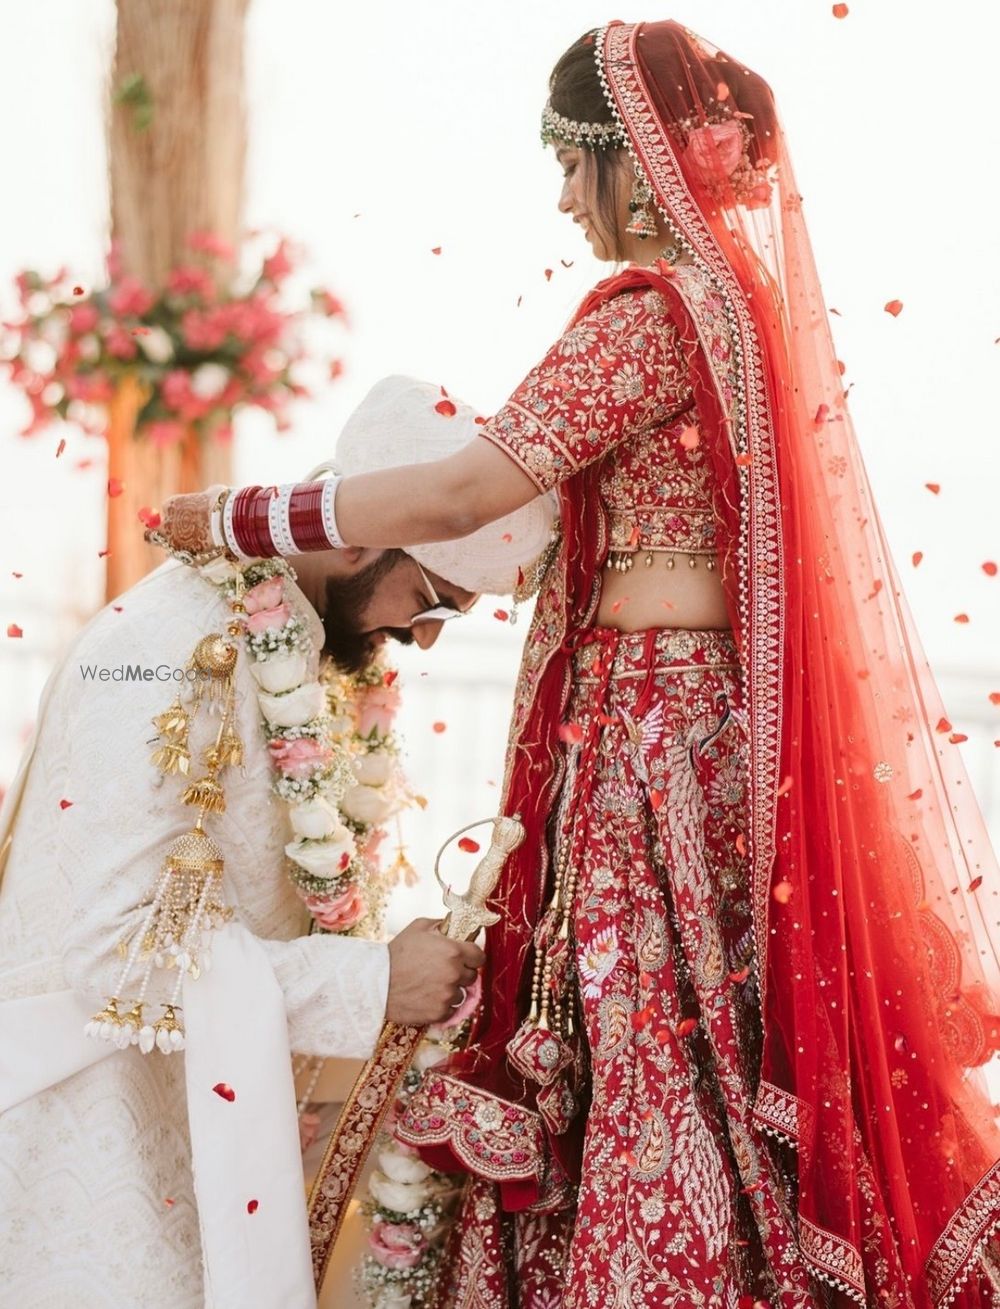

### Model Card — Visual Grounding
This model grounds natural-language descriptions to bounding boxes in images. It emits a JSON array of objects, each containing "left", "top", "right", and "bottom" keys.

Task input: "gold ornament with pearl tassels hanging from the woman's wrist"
[{"left": 85, "top": 635, "right": 243, "bottom": 1055}]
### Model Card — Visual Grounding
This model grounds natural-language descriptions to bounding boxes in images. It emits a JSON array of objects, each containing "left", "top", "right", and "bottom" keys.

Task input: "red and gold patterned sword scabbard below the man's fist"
[{"left": 309, "top": 1022, "right": 424, "bottom": 1292}]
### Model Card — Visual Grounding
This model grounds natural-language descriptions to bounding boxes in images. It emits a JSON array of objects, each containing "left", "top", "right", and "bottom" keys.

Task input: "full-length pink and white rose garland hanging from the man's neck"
[{"left": 199, "top": 547, "right": 480, "bottom": 1309}]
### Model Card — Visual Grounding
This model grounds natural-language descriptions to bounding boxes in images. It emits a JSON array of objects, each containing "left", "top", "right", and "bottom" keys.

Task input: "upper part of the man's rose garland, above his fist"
[{"left": 199, "top": 559, "right": 418, "bottom": 937}]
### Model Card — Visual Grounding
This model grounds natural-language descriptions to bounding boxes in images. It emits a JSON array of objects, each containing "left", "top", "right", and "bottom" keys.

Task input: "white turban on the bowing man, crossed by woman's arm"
[{"left": 321, "top": 377, "right": 559, "bottom": 596}]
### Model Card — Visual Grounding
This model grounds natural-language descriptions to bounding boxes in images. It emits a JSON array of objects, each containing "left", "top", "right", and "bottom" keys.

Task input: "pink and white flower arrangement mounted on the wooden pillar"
[{"left": 3, "top": 233, "right": 344, "bottom": 445}]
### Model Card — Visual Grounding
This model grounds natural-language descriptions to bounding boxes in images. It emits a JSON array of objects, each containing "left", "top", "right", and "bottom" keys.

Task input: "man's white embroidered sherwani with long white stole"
[{"left": 0, "top": 563, "right": 389, "bottom": 1309}]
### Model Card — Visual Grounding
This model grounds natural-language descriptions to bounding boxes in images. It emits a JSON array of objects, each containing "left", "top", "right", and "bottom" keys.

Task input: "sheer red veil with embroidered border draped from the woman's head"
[{"left": 434, "top": 22, "right": 1000, "bottom": 1309}]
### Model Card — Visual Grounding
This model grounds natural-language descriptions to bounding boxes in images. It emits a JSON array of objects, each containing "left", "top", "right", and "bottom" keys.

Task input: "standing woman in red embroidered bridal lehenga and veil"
[{"left": 160, "top": 22, "right": 1000, "bottom": 1309}]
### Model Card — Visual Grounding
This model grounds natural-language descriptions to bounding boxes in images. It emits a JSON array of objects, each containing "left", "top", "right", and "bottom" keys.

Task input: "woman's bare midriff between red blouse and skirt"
[{"left": 597, "top": 554, "right": 730, "bottom": 632}]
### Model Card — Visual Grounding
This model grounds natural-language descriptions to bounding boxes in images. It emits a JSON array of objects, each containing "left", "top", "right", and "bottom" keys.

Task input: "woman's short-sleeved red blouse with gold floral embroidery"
[{"left": 482, "top": 288, "right": 716, "bottom": 555}]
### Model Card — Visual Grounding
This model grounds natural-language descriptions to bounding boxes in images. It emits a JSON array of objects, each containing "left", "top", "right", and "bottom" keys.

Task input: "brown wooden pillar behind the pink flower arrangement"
[{"left": 106, "top": 0, "right": 249, "bottom": 600}]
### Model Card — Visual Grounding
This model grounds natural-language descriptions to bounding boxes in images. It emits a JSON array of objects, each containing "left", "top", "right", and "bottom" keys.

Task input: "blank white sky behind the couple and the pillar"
[{"left": 0, "top": 0, "right": 1000, "bottom": 916}]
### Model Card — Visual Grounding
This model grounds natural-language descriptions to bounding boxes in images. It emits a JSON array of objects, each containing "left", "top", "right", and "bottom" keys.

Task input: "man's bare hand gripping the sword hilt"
[{"left": 385, "top": 918, "right": 486, "bottom": 1028}]
